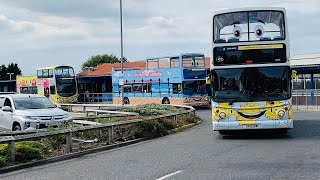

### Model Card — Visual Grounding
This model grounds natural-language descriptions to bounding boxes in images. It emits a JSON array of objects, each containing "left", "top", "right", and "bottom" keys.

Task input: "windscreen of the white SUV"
[{"left": 13, "top": 97, "right": 55, "bottom": 110}]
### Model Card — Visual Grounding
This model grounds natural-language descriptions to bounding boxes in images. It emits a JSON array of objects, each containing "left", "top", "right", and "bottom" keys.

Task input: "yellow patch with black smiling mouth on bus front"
[{"left": 236, "top": 102, "right": 266, "bottom": 124}]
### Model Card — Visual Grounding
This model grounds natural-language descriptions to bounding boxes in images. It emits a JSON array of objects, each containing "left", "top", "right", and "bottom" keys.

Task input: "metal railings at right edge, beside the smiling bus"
[{"left": 292, "top": 89, "right": 320, "bottom": 109}]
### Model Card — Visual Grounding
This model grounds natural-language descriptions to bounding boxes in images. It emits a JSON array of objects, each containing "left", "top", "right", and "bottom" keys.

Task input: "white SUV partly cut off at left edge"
[{"left": 0, "top": 94, "right": 72, "bottom": 131}]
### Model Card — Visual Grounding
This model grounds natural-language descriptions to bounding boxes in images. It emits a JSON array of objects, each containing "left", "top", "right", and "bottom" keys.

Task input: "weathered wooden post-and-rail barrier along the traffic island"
[{"left": 0, "top": 106, "right": 195, "bottom": 162}]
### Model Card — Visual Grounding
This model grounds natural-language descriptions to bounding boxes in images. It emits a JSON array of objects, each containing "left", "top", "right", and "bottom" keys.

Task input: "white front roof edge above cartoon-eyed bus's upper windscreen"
[{"left": 213, "top": 7, "right": 286, "bottom": 15}]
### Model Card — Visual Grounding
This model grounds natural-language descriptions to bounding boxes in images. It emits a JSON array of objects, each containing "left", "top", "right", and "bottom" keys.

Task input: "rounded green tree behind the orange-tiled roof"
[{"left": 82, "top": 54, "right": 127, "bottom": 69}]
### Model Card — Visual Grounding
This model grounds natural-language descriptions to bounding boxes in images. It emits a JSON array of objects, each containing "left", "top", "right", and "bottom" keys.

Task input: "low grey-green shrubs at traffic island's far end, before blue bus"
[{"left": 122, "top": 104, "right": 184, "bottom": 116}]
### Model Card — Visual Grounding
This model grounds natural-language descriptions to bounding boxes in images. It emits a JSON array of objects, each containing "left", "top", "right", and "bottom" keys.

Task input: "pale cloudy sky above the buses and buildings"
[{"left": 0, "top": 0, "right": 320, "bottom": 75}]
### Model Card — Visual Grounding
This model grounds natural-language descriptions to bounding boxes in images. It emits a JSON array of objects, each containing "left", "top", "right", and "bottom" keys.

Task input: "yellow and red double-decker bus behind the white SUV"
[{"left": 17, "top": 65, "right": 78, "bottom": 104}]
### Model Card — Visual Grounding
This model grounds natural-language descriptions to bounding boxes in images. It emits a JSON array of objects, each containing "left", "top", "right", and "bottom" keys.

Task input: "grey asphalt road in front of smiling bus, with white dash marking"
[{"left": 0, "top": 110, "right": 320, "bottom": 180}]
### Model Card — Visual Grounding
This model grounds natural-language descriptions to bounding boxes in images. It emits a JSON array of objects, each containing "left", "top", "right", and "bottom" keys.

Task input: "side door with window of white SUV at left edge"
[{"left": 0, "top": 98, "right": 13, "bottom": 130}]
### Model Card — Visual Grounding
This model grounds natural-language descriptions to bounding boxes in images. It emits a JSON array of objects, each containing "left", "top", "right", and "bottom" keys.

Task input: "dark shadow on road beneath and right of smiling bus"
[{"left": 217, "top": 120, "right": 320, "bottom": 140}]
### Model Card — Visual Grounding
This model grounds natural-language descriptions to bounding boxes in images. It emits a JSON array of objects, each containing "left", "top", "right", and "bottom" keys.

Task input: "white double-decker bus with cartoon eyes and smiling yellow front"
[{"left": 210, "top": 8, "right": 293, "bottom": 134}]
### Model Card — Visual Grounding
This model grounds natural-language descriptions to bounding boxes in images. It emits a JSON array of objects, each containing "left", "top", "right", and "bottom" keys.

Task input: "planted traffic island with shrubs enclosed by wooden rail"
[{"left": 0, "top": 104, "right": 201, "bottom": 173}]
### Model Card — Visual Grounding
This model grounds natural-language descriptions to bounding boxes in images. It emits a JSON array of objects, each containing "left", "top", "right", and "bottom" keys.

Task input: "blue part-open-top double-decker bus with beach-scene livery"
[{"left": 112, "top": 53, "right": 209, "bottom": 106}]
